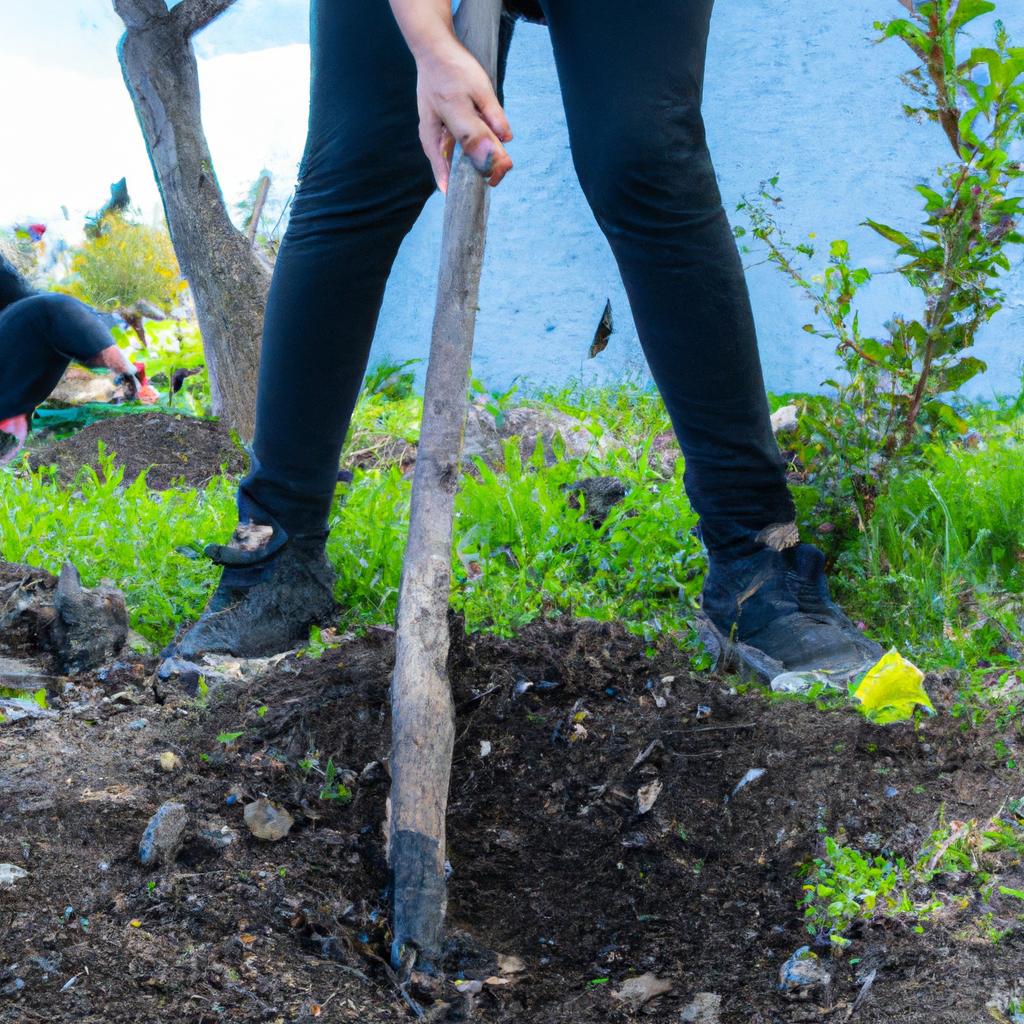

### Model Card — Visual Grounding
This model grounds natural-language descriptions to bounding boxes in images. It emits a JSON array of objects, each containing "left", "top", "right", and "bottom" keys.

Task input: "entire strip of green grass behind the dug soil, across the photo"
[{"left": 6, "top": 376, "right": 1024, "bottom": 688}]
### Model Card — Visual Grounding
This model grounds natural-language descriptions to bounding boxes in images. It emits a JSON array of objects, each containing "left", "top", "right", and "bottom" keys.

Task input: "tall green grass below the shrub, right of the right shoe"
[{"left": 840, "top": 420, "right": 1024, "bottom": 668}]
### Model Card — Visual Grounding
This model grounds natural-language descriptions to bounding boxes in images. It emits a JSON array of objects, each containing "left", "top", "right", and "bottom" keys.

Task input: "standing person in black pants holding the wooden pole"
[{"left": 174, "top": 0, "right": 881, "bottom": 675}]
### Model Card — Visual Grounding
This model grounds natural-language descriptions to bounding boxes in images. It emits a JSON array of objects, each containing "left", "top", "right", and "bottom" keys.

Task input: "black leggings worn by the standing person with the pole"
[{"left": 240, "top": 0, "right": 794, "bottom": 555}]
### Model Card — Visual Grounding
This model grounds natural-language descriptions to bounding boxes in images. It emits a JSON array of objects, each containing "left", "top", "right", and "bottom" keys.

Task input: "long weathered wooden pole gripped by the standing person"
[{"left": 389, "top": 0, "right": 501, "bottom": 968}]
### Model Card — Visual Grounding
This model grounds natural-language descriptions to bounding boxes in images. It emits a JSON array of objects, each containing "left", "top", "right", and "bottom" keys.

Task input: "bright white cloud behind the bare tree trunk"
[{"left": 0, "top": 44, "right": 309, "bottom": 237}]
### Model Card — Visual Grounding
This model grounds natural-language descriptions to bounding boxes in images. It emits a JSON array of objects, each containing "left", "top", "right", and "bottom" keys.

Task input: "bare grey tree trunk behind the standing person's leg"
[{"left": 114, "top": 0, "right": 270, "bottom": 440}]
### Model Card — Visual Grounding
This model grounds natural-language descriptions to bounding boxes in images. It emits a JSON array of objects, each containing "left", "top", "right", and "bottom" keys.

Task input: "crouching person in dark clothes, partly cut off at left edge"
[{"left": 0, "top": 249, "right": 157, "bottom": 465}]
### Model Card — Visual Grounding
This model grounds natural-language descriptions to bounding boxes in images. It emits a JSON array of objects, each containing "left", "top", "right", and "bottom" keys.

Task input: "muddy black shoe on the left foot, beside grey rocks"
[{"left": 170, "top": 523, "right": 337, "bottom": 660}]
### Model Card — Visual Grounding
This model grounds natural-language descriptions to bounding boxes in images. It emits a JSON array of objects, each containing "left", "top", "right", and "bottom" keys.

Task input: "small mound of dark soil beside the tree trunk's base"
[{"left": 30, "top": 413, "right": 248, "bottom": 490}]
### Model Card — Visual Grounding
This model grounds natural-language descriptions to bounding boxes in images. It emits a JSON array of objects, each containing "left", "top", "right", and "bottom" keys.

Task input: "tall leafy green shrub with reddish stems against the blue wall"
[{"left": 738, "top": 0, "right": 1024, "bottom": 542}]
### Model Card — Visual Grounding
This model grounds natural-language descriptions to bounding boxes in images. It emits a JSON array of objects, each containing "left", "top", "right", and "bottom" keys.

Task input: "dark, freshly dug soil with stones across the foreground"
[{"left": 0, "top": 621, "right": 1024, "bottom": 1024}]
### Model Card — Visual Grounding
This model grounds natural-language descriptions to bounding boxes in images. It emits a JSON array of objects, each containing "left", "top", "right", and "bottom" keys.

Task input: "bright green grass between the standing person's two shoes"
[{"left": 329, "top": 432, "right": 702, "bottom": 640}]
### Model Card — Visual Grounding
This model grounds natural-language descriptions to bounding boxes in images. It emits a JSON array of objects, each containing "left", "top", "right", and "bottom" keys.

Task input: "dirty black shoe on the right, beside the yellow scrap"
[{"left": 701, "top": 545, "right": 882, "bottom": 680}]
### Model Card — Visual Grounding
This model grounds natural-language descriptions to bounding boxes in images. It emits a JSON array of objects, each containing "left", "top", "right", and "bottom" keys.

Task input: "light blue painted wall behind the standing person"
[{"left": 374, "top": 0, "right": 1024, "bottom": 396}]
